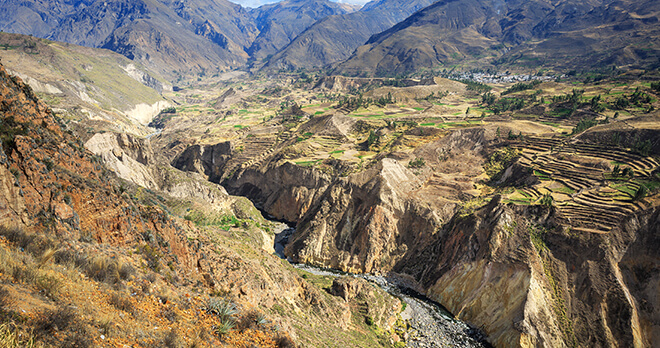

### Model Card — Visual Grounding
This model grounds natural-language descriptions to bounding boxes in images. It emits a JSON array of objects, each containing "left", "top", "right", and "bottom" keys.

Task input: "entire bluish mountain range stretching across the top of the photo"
[{"left": 0, "top": 0, "right": 660, "bottom": 79}]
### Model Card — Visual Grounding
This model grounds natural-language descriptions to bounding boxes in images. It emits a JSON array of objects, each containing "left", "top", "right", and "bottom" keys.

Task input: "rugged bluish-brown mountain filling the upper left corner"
[{"left": 0, "top": 0, "right": 258, "bottom": 80}]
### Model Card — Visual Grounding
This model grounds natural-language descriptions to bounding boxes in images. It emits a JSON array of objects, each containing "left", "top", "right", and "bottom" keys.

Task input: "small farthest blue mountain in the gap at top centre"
[{"left": 247, "top": 0, "right": 356, "bottom": 60}]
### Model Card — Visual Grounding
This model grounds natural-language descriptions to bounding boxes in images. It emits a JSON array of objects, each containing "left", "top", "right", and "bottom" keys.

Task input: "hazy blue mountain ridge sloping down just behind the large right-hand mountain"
[{"left": 265, "top": 0, "right": 433, "bottom": 70}]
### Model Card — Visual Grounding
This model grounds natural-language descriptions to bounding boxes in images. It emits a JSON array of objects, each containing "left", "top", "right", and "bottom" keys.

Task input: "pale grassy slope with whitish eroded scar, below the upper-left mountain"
[{"left": 0, "top": 33, "right": 172, "bottom": 136}]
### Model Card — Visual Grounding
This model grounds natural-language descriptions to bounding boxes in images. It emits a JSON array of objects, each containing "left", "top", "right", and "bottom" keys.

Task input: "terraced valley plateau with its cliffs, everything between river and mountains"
[{"left": 148, "top": 64, "right": 660, "bottom": 347}]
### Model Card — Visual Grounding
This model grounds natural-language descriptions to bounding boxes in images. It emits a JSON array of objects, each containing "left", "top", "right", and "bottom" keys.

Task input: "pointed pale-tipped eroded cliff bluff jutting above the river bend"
[{"left": 286, "top": 159, "right": 440, "bottom": 273}]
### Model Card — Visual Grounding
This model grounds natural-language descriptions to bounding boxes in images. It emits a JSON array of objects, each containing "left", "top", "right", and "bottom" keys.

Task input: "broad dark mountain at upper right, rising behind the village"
[{"left": 336, "top": 0, "right": 660, "bottom": 75}]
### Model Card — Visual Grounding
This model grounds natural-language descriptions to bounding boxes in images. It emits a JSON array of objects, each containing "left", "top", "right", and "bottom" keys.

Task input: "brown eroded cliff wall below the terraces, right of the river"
[{"left": 186, "top": 112, "right": 658, "bottom": 347}]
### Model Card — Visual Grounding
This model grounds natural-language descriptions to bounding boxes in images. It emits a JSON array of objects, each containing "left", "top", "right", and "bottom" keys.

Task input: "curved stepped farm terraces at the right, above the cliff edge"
[{"left": 509, "top": 137, "right": 660, "bottom": 233}]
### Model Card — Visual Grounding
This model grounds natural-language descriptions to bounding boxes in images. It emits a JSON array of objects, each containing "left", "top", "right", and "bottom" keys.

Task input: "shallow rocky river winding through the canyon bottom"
[{"left": 274, "top": 222, "right": 491, "bottom": 348}]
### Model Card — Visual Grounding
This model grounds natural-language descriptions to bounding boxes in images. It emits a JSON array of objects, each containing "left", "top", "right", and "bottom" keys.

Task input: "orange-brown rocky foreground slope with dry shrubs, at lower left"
[{"left": 0, "top": 59, "right": 412, "bottom": 347}]
